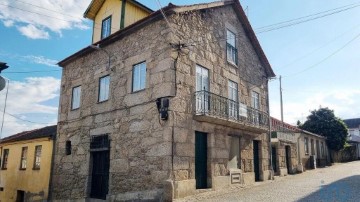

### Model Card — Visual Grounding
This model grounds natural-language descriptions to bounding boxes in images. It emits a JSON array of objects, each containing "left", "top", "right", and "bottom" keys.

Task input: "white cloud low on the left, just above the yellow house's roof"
[{"left": 0, "top": 77, "right": 60, "bottom": 137}]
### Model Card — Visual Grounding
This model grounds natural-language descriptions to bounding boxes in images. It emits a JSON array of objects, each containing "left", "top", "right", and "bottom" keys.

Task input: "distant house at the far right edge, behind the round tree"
[{"left": 344, "top": 118, "right": 360, "bottom": 159}]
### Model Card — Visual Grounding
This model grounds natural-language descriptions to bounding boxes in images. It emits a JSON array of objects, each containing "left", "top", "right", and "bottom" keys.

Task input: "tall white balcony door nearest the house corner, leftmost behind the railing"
[{"left": 196, "top": 65, "right": 210, "bottom": 113}]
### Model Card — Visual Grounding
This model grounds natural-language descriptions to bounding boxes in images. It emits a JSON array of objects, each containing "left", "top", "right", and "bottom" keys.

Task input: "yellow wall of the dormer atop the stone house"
[{"left": 93, "top": 0, "right": 149, "bottom": 43}]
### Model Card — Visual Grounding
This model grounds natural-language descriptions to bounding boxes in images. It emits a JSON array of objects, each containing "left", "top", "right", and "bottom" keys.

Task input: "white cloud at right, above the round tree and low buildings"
[{"left": 271, "top": 89, "right": 360, "bottom": 124}]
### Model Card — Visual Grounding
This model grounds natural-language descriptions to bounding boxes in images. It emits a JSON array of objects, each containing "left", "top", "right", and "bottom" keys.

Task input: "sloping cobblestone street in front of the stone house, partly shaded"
[{"left": 175, "top": 161, "right": 360, "bottom": 202}]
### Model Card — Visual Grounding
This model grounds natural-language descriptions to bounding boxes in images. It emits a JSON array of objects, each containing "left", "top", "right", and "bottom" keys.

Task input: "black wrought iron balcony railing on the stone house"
[{"left": 194, "top": 90, "right": 269, "bottom": 127}]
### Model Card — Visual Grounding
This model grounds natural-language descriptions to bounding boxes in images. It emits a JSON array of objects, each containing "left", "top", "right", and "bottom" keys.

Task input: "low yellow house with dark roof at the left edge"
[{"left": 0, "top": 125, "right": 56, "bottom": 202}]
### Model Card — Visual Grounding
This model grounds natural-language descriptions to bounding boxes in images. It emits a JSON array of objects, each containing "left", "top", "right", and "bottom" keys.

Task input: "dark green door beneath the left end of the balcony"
[{"left": 195, "top": 131, "right": 207, "bottom": 189}]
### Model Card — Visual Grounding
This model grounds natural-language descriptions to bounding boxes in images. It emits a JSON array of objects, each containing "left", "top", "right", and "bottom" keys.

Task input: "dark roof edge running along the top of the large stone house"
[{"left": 58, "top": 0, "right": 275, "bottom": 78}]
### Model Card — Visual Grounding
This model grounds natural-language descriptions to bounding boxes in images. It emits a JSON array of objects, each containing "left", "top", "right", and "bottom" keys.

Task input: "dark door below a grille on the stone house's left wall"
[{"left": 90, "top": 150, "right": 110, "bottom": 200}]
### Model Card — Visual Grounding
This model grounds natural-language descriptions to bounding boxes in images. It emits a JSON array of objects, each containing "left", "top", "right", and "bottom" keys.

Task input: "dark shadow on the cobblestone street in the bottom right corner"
[{"left": 298, "top": 175, "right": 360, "bottom": 202}]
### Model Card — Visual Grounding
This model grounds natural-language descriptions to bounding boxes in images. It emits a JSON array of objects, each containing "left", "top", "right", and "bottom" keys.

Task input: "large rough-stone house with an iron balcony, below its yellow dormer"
[{"left": 52, "top": 0, "right": 275, "bottom": 201}]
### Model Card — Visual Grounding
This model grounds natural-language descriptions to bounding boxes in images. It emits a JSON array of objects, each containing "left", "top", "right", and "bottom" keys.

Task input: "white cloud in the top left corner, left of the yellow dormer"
[{"left": 0, "top": 0, "right": 90, "bottom": 39}]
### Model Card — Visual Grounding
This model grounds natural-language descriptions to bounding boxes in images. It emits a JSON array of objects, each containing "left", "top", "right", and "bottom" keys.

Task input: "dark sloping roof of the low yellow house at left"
[{"left": 0, "top": 125, "right": 57, "bottom": 144}]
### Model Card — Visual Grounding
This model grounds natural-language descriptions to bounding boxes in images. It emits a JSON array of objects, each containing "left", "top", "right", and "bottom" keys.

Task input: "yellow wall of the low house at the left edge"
[{"left": 0, "top": 138, "right": 53, "bottom": 202}]
